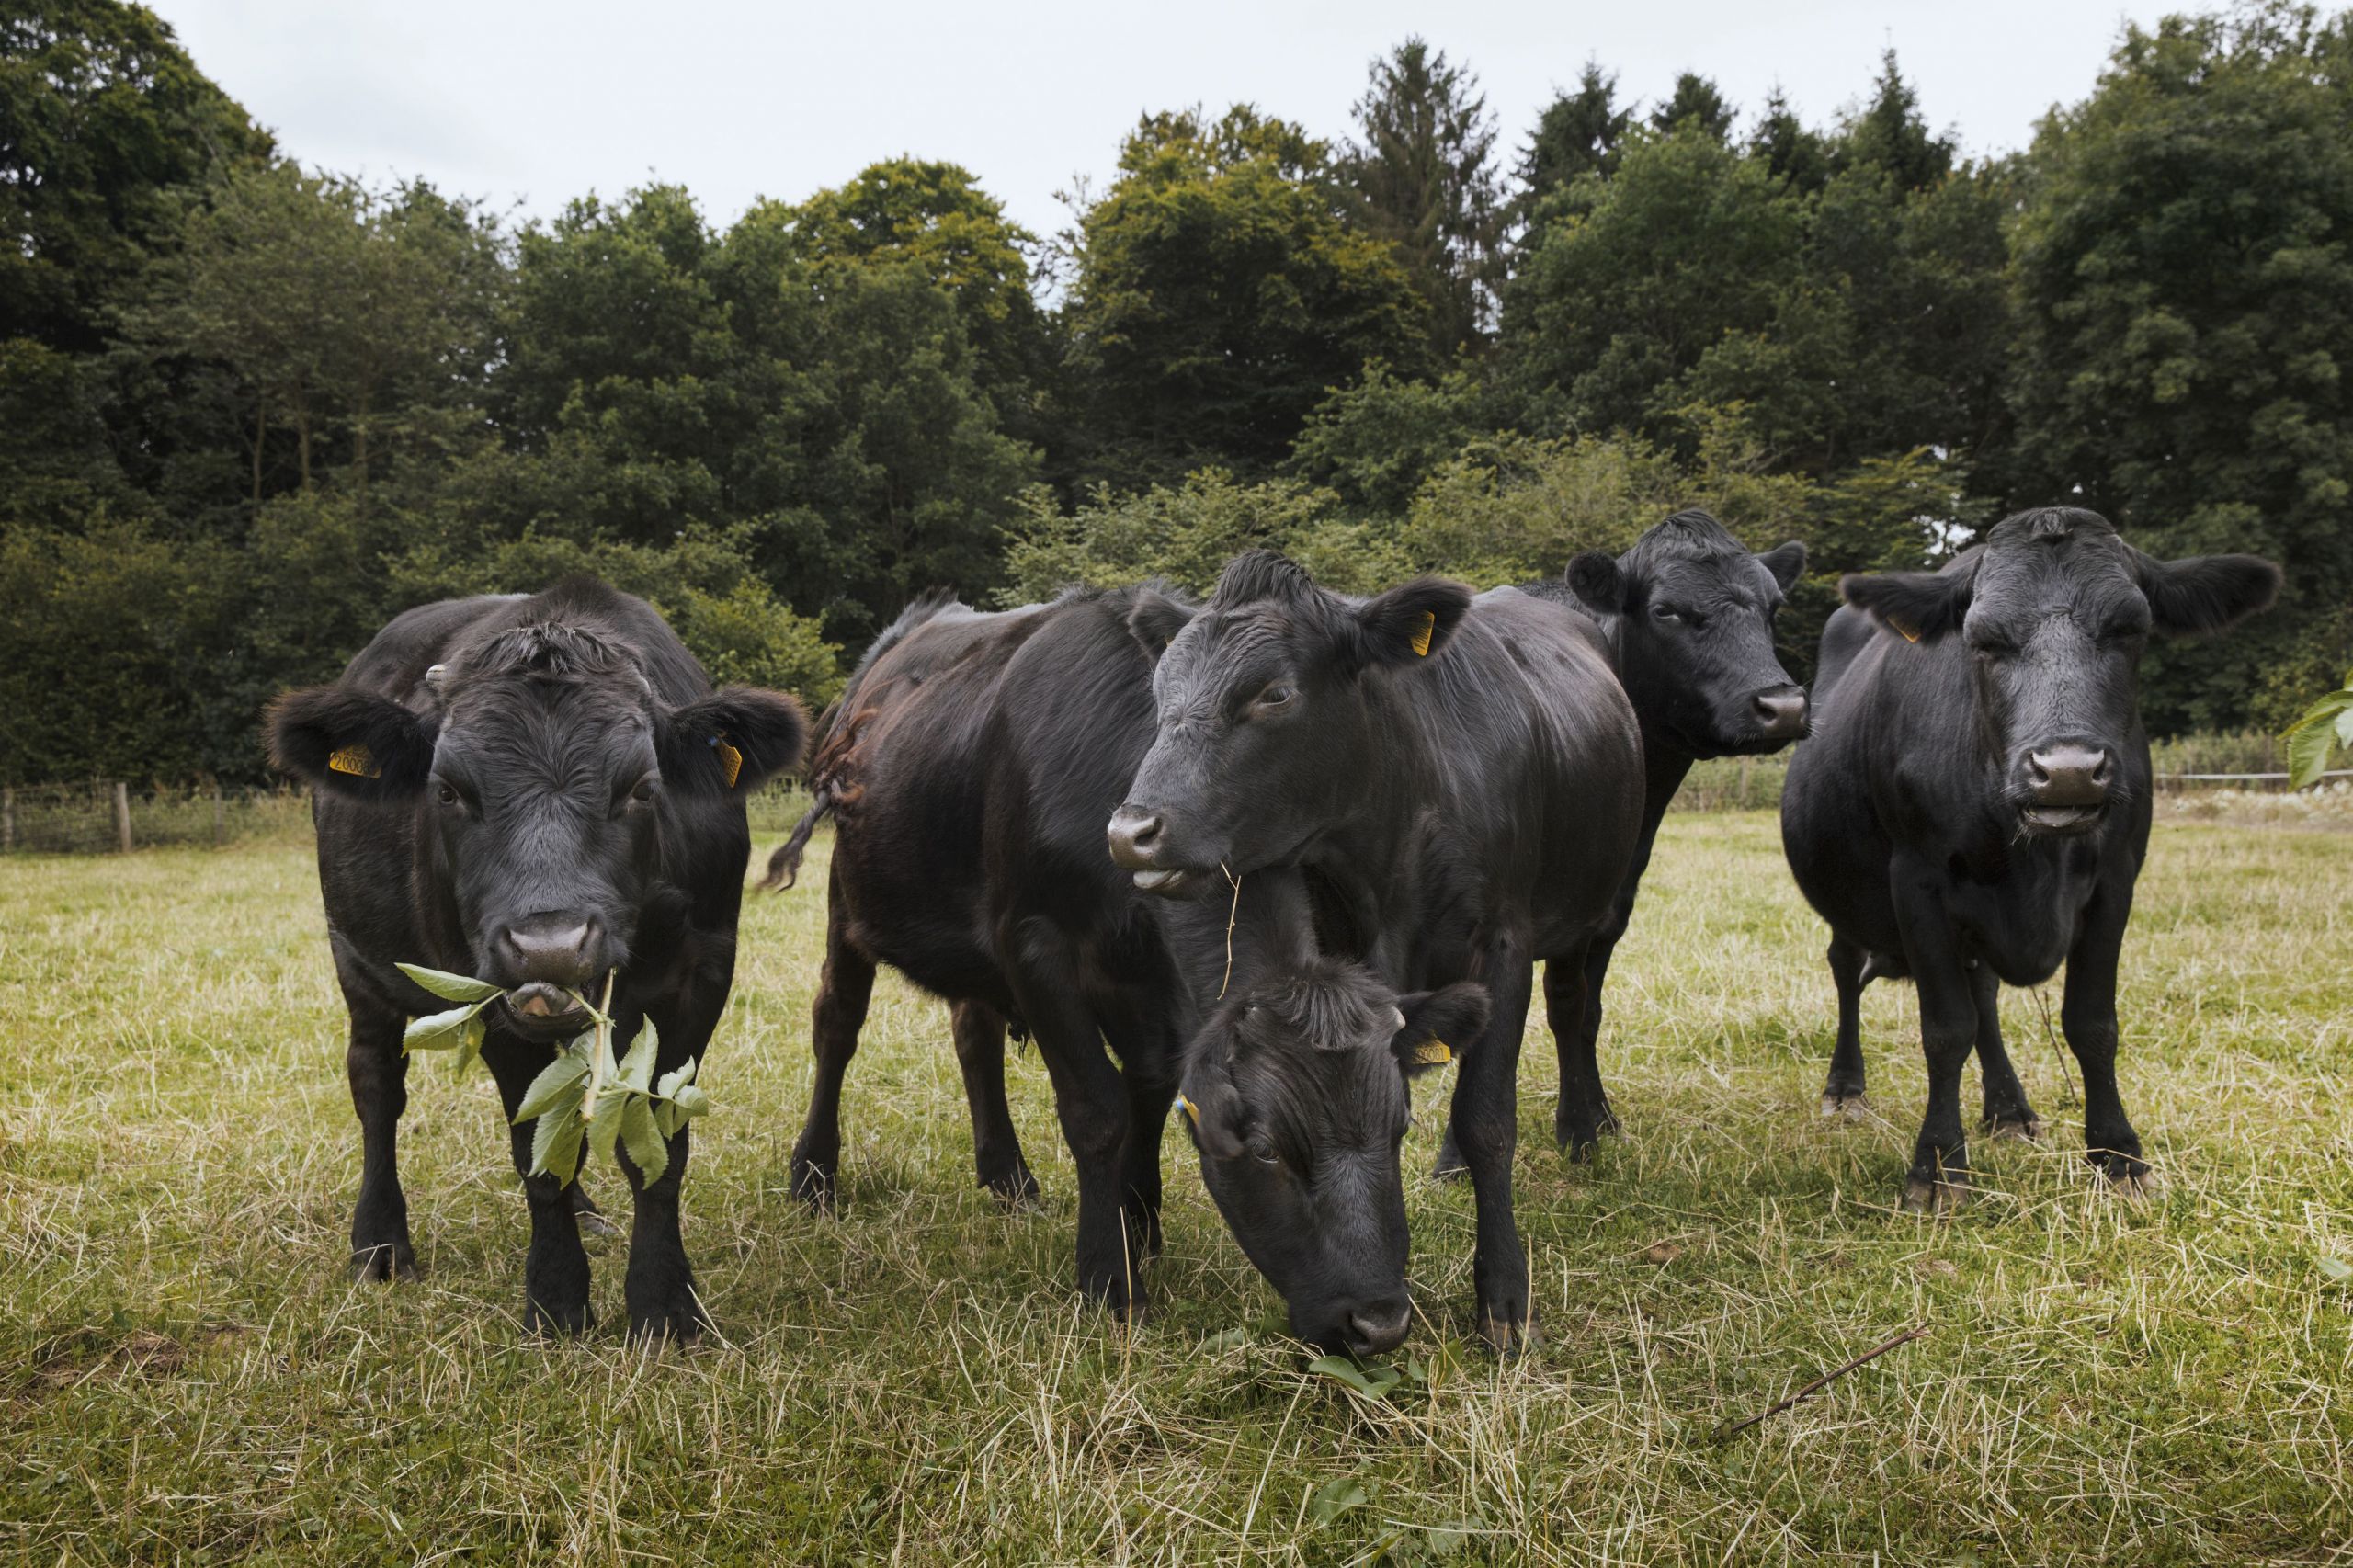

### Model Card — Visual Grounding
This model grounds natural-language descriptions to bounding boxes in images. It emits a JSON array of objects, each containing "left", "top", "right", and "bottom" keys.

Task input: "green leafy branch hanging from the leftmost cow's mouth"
[{"left": 398, "top": 963, "right": 710, "bottom": 1184}]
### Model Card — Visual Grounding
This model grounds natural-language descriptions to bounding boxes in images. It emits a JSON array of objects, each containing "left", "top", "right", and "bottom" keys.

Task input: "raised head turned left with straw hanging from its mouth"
[{"left": 1110, "top": 551, "right": 1471, "bottom": 892}]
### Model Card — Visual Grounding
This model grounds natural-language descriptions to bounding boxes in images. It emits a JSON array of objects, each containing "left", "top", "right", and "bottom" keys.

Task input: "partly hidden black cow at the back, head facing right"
[{"left": 1438, "top": 511, "right": 1805, "bottom": 1175}]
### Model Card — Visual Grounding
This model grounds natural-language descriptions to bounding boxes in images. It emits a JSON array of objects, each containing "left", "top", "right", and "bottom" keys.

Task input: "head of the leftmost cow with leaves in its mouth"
[{"left": 268, "top": 597, "right": 807, "bottom": 1036}]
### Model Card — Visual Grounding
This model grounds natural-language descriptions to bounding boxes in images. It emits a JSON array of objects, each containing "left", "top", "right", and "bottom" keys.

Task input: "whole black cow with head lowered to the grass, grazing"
[{"left": 790, "top": 591, "right": 1475, "bottom": 1354}]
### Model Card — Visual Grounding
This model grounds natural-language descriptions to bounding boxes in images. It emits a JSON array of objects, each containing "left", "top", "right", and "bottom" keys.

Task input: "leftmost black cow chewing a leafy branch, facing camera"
[{"left": 268, "top": 577, "right": 807, "bottom": 1337}]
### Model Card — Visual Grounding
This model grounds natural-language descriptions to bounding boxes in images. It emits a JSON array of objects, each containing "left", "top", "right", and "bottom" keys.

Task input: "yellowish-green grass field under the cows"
[{"left": 0, "top": 814, "right": 2353, "bottom": 1563}]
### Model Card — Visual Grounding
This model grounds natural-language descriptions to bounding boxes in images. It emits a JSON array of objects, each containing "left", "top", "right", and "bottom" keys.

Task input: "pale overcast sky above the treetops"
[{"left": 151, "top": 0, "right": 2186, "bottom": 233}]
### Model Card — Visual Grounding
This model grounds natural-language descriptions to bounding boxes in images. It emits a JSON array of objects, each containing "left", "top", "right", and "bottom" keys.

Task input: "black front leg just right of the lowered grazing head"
[{"left": 1454, "top": 942, "right": 1537, "bottom": 1351}]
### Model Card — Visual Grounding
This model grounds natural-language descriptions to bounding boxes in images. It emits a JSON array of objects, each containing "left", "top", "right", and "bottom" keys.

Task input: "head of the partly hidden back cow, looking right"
[{"left": 1570, "top": 511, "right": 1807, "bottom": 756}]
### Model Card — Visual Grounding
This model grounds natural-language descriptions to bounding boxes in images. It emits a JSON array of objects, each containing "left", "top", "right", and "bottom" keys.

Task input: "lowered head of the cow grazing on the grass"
[{"left": 1184, "top": 959, "right": 1487, "bottom": 1354}]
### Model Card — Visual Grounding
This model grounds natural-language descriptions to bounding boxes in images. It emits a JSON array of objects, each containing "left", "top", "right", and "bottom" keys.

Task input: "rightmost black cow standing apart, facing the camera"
[{"left": 1781, "top": 506, "right": 2280, "bottom": 1210}]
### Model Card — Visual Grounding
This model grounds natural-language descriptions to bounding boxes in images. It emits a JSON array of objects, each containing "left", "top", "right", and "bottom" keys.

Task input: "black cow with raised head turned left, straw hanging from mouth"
[{"left": 1108, "top": 551, "right": 1643, "bottom": 1345}]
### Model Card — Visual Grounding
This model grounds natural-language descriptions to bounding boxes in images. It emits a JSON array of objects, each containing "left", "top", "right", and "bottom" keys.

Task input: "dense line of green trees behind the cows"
[{"left": 0, "top": 0, "right": 2353, "bottom": 781}]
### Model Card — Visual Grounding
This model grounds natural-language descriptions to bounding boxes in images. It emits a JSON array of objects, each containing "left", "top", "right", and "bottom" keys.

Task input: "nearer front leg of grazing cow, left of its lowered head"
[{"left": 1009, "top": 937, "right": 1146, "bottom": 1324}]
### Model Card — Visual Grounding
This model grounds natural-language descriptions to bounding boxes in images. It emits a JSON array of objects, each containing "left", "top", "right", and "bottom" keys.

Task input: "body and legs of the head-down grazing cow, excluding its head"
[{"left": 793, "top": 594, "right": 1190, "bottom": 1313}]
